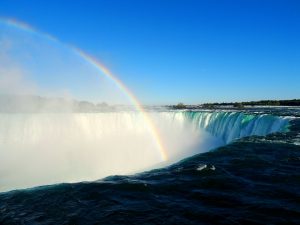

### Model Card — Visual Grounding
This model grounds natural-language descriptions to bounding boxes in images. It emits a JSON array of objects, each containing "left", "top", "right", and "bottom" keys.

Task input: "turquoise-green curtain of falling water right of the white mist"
[{"left": 181, "top": 111, "right": 289, "bottom": 144}]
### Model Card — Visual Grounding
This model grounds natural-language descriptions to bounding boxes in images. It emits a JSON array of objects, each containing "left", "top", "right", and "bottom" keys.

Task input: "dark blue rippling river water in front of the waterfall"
[{"left": 0, "top": 109, "right": 300, "bottom": 225}]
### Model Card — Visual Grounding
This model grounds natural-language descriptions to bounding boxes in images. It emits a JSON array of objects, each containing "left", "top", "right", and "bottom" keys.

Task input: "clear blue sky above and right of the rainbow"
[{"left": 0, "top": 0, "right": 300, "bottom": 104}]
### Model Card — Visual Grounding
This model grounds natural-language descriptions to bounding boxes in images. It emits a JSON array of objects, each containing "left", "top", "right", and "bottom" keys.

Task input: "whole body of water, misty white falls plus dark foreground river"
[{"left": 0, "top": 108, "right": 300, "bottom": 225}]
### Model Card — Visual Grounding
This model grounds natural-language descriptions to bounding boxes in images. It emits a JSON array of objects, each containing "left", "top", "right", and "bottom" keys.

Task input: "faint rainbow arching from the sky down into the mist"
[{"left": 0, "top": 18, "right": 168, "bottom": 161}]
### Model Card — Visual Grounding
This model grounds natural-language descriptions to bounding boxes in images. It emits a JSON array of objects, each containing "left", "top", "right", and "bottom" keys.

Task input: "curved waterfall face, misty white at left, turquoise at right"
[{"left": 0, "top": 111, "right": 287, "bottom": 191}]
